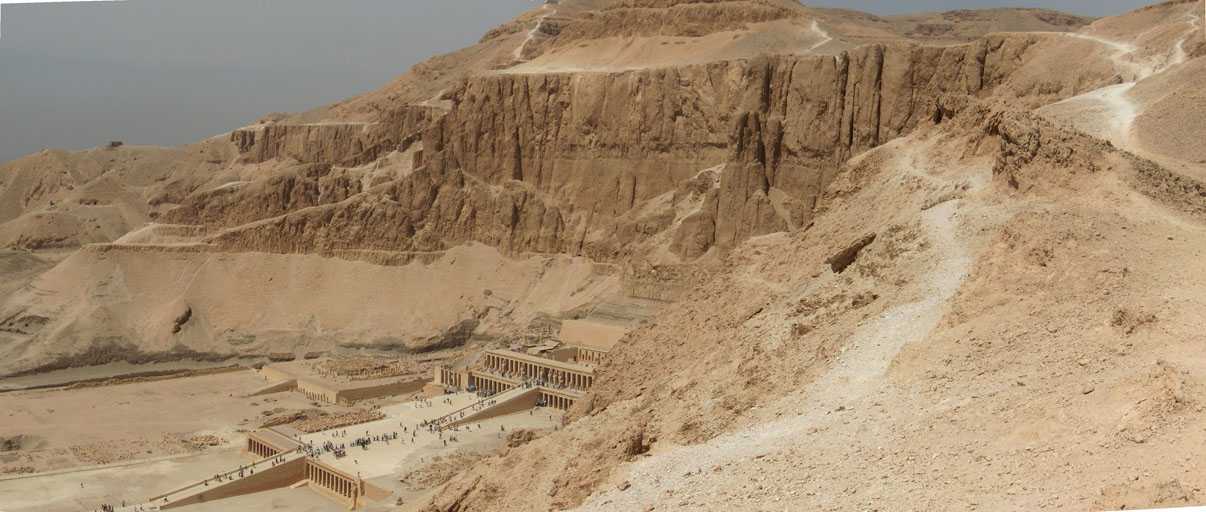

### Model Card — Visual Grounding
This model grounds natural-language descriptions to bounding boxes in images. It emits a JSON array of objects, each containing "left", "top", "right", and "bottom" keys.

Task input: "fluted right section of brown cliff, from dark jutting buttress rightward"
[{"left": 715, "top": 45, "right": 985, "bottom": 251}]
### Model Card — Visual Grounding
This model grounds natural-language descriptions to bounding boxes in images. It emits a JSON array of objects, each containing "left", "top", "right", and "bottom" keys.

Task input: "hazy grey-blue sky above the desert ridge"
[{"left": 0, "top": 0, "right": 1167, "bottom": 161}]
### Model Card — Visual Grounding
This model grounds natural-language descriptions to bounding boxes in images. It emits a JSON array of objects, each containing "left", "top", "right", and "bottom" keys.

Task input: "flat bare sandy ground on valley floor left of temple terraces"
[{"left": 0, "top": 371, "right": 323, "bottom": 471}]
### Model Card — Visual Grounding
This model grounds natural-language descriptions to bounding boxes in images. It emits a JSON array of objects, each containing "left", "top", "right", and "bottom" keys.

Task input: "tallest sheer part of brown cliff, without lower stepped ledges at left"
[{"left": 427, "top": 45, "right": 987, "bottom": 257}]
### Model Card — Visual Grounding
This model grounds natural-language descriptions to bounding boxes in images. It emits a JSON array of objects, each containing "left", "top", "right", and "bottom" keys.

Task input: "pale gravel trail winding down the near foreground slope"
[{"left": 580, "top": 140, "right": 991, "bottom": 511}]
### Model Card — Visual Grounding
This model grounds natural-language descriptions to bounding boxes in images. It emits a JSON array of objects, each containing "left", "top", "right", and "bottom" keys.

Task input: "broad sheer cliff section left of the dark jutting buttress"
[{"left": 426, "top": 63, "right": 743, "bottom": 203}]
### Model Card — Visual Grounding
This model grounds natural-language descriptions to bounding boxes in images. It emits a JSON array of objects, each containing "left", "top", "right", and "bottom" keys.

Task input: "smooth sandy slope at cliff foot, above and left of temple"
[{"left": 0, "top": 239, "right": 619, "bottom": 372}]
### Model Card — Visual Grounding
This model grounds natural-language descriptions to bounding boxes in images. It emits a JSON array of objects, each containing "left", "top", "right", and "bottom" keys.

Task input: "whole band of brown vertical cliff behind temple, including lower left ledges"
[{"left": 209, "top": 39, "right": 1066, "bottom": 260}]
